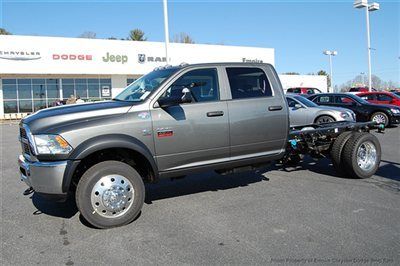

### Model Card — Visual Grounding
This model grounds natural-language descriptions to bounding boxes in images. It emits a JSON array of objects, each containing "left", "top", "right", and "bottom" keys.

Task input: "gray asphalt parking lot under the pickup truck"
[{"left": 0, "top": 124, "right": 400, "bottom": 265}]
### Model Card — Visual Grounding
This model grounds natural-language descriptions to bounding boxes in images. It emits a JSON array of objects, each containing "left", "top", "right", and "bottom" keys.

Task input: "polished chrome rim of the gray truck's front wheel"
[{"left": 90, "top": 175, "right": 135, "bottom": 218}]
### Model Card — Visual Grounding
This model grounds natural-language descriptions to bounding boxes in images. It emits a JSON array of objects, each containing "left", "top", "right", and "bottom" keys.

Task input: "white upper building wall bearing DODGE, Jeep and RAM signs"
[{"left": 0, "top": 35, "right": 274, "bottom": 75}]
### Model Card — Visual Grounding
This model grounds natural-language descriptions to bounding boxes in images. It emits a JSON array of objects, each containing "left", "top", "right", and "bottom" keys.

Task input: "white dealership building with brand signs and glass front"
[{"left": 0, "top": 35, "right": 327, "bottom": 118}]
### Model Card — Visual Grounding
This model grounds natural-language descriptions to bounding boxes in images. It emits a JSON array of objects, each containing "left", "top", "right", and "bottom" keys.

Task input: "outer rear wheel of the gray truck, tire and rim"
[{"left": 342, "top": 132, "right": 381, "bottom": 178}]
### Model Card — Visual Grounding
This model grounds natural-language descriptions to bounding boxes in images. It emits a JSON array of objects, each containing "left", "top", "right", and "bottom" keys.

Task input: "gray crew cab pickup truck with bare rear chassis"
[{"left": 19, "top": 63, "right": 381, "bottom": 228}]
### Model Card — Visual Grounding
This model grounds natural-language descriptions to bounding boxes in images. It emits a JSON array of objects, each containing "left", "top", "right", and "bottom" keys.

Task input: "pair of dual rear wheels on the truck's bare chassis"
[{"left": 331, "top": 132, "right": 381, "bottom": 178}]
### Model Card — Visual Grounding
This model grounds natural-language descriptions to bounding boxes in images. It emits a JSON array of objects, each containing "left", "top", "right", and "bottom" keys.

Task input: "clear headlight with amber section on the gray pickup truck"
[{"left": 33, "top": 135, "right": 72, "bottom": 154}]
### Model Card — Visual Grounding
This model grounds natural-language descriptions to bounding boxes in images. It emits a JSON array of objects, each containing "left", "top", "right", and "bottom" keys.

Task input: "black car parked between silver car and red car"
[{"left": 308, "top": 93, "right": 400, "bottom": 126}]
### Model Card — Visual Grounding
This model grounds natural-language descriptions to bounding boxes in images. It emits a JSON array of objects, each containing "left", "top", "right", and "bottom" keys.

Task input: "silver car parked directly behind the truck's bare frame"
[{"left": 286, "top": 94, "right": 356, "bottom": 126}]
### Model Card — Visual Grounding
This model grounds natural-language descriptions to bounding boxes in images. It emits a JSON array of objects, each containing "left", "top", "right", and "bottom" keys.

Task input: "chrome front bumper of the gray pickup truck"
[{"left": 18, "top": 155, "right": 67, "bottom": 194}]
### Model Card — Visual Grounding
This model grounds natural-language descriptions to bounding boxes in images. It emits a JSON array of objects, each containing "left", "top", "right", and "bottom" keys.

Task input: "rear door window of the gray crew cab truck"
[{"left": 226, "top": 67, "right": 272, "bottom": 99}]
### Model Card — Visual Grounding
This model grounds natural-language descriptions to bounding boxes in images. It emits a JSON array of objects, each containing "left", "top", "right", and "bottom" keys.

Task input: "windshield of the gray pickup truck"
[{"left": 113, "top": 68, "right": 178, "bottom": 102}]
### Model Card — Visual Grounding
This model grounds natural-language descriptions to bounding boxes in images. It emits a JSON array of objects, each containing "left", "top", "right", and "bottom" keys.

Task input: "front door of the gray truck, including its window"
[{"left": 151, "top": 68, "right": 229, "bottom": 172}]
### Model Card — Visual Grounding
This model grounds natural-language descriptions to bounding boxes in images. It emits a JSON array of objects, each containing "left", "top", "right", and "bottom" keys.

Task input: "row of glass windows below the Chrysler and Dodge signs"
[{"left": 2, "top": 78, "right": 111, "bottom": 114}]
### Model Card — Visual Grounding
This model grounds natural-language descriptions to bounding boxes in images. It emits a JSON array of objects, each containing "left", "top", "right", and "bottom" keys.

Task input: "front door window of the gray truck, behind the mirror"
[{"left": 161, "top": 68, "right": 219, "bottom": 102}]
